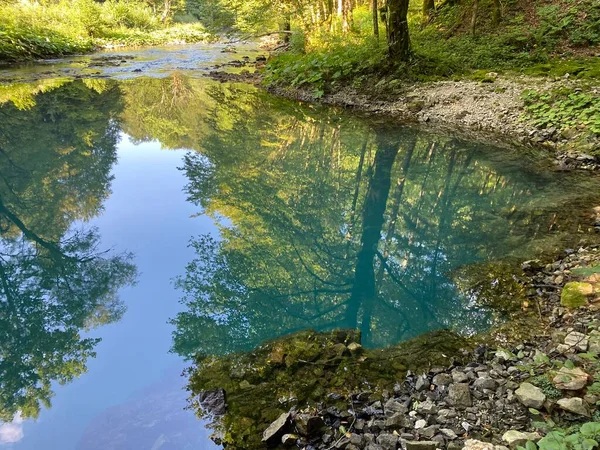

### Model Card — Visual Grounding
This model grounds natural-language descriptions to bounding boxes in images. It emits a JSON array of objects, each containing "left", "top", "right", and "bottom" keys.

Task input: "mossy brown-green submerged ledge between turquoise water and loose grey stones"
[{"left": 189, "top": 330, "right": 468, "bottom": 449}]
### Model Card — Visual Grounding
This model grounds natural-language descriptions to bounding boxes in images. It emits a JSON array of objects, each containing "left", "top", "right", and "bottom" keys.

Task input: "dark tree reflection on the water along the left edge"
[{"left": 0, "top": 82, "right": 135, "bottom": 421}]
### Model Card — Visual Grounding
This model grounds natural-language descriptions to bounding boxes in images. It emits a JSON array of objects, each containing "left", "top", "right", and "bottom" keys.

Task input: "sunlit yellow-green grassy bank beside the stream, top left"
[{"left": 0, "top": 0, "right": 209, "bottom": 61}]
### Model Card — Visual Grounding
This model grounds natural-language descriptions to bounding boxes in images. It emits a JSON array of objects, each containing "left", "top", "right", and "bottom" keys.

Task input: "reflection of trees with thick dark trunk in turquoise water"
[{"left": 162, "top": 76, "right": 592, "bottom": 356}]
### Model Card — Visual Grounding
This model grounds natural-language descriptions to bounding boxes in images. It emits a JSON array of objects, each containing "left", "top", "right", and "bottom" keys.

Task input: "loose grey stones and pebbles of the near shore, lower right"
[{"left": 199, "top": 247, "right": 600, "bottom": 450}]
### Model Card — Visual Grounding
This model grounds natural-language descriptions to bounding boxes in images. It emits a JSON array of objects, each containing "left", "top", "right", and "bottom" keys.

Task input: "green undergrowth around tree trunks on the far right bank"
[{"left": 267, "top": 0, "right": 600, "bottom": 92}]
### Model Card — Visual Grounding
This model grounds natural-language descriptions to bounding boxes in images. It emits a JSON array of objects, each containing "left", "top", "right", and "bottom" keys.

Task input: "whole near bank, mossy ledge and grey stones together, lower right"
[{"left": 196, "top": 248, "right": 600, "bottom": 450}]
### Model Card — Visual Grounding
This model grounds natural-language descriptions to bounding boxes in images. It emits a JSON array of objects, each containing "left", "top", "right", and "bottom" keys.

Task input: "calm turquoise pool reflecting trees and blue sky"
[{"left": 0, "top": 73, "right": 600, "bottom": 450}]
